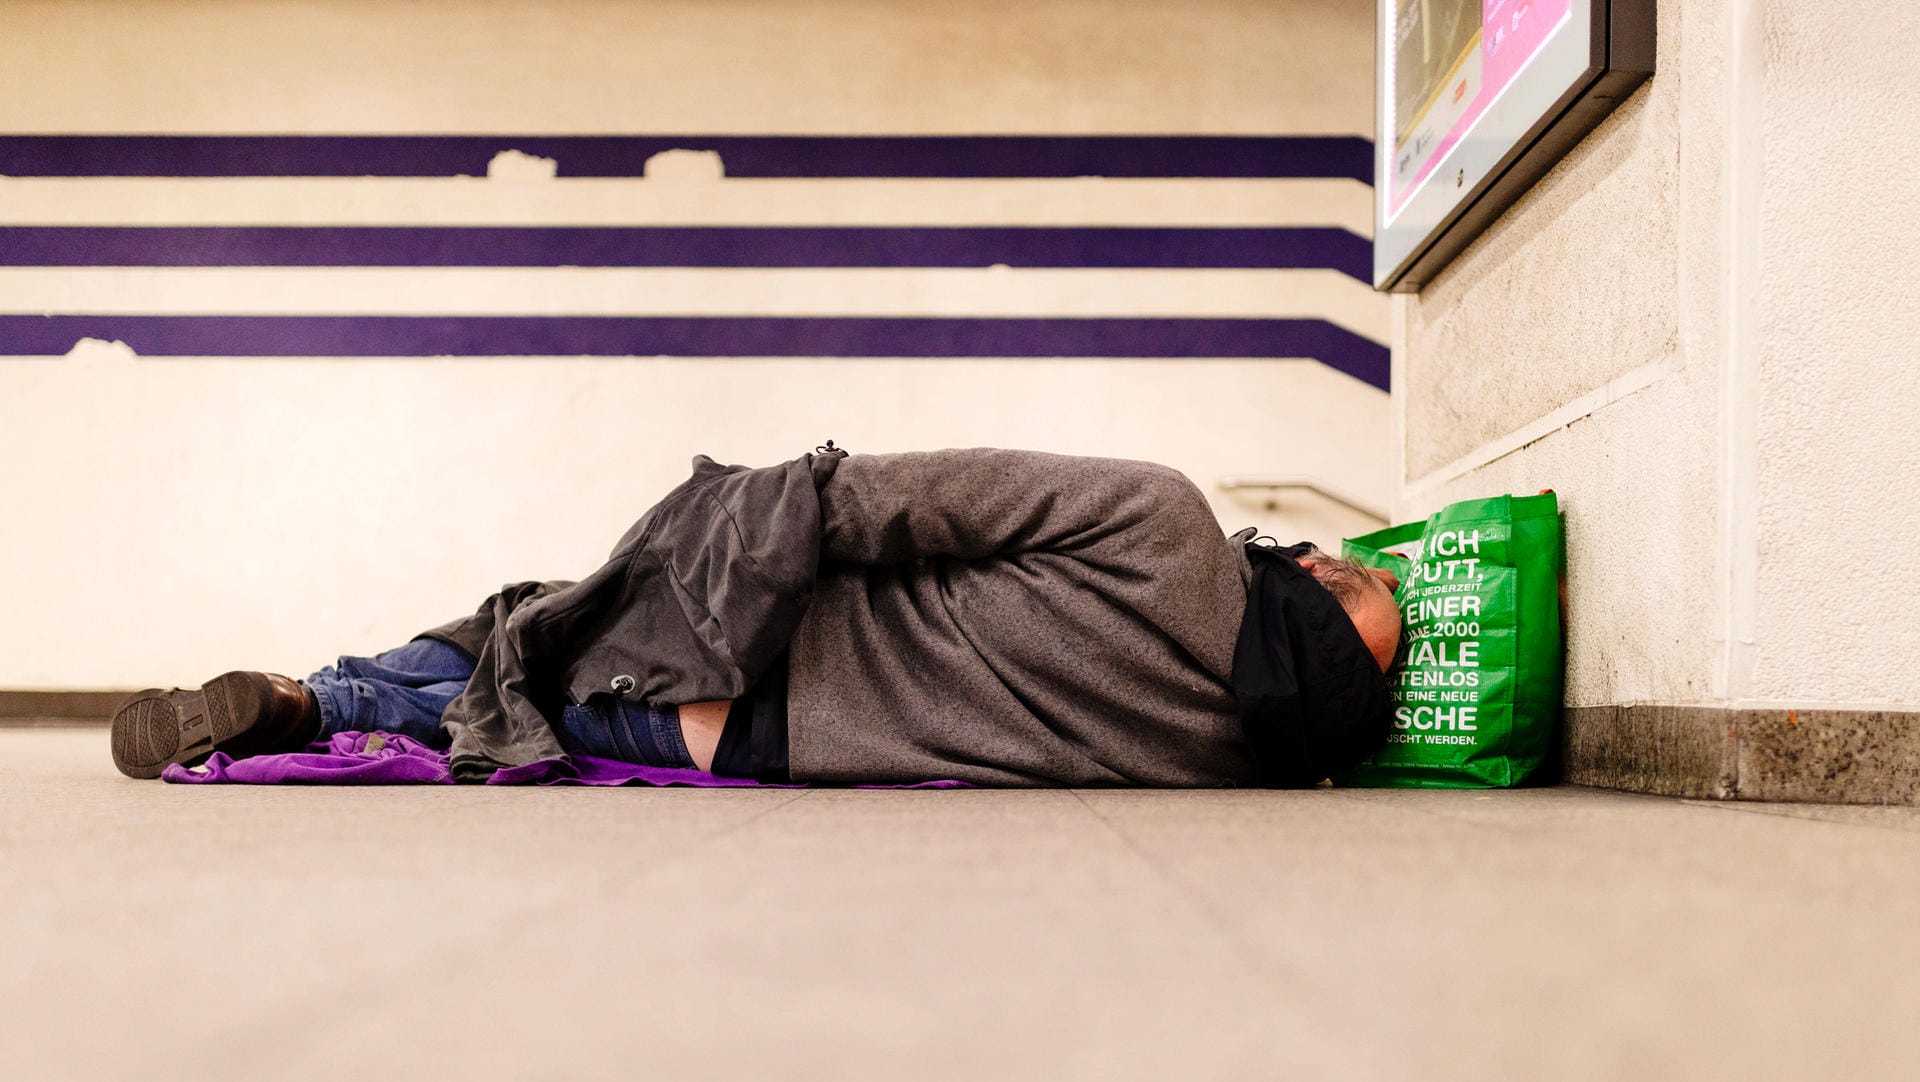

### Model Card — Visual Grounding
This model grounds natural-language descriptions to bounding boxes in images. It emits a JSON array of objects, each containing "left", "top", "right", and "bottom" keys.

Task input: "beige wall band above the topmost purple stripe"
[{"left": 0, "top": 0, "right": 1373, "bottom": 134}]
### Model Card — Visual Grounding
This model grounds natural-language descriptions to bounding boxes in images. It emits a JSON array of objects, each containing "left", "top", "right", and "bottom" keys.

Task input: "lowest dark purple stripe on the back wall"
[{"left": 0, "top": 315, "right": 1388, "bottom": 389}]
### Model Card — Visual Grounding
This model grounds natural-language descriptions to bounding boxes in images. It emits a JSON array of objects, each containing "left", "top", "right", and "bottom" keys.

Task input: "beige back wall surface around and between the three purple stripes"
[{"left": 0, "top": 0, "right": 1392, "bottom": 689}]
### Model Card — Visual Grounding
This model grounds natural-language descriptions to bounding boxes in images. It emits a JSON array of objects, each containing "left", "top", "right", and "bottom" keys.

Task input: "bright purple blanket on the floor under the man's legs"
[{"left": 159, "top": 733, "right": 972, "bottom": 788}]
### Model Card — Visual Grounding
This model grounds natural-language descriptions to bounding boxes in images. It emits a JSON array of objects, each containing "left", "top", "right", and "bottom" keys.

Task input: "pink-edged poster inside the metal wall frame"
[{"left": 1390, "top": 0, "right": 1572, "bottom": 211}]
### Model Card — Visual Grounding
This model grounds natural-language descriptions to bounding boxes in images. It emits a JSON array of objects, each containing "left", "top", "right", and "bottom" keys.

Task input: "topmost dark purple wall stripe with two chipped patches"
[{"left": 0, "top": 134, "right": 1373, "bottom": 184}]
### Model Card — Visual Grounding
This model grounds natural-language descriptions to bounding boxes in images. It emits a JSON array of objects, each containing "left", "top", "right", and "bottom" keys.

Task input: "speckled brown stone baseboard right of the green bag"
[{"left": 1565, "top": 704, "right": 1920, "bottom": 804}]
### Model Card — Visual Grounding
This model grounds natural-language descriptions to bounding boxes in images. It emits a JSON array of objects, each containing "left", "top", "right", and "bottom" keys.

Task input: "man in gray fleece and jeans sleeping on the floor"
[{"left": 113, "top": 443, "right": 1400, "bottom": 787}]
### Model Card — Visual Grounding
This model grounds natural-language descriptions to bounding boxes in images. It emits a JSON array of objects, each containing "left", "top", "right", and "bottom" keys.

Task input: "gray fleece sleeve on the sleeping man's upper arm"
[{"left": 820, "top": 449, "right": 1221, "bottom": 574}]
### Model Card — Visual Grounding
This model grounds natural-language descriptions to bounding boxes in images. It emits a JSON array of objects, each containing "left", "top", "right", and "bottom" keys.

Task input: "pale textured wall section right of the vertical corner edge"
[{"left": 1745, "top": 0, "right": 1920, "bottom": 704}]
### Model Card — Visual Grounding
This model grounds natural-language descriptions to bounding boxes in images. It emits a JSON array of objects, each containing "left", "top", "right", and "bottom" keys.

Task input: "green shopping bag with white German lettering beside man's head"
[{"left": 1336, "top": 493, "right": 1565, "bottom": 788}]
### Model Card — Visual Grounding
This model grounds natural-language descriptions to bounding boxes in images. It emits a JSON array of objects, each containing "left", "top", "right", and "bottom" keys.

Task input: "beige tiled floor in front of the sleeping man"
[{"left": 0, "top": 729, "right": 1920, "bottom": 1082}]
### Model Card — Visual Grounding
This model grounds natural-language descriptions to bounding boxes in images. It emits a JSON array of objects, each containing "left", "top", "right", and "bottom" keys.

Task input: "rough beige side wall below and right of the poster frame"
[{"left": 1394, "top": 0, "right": 1920, "bottom": 706}]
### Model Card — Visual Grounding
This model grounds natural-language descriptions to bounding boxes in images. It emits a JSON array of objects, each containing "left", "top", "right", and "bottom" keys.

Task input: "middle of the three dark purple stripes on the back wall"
[{"left": 0, "top": 226, "right": 1373, "bottom": 282}]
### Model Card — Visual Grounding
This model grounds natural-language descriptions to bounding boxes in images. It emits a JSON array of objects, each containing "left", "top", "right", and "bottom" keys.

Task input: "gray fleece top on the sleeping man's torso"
[{"left": 787, "top": 451, "right": 1258, "bottom": 787}]
